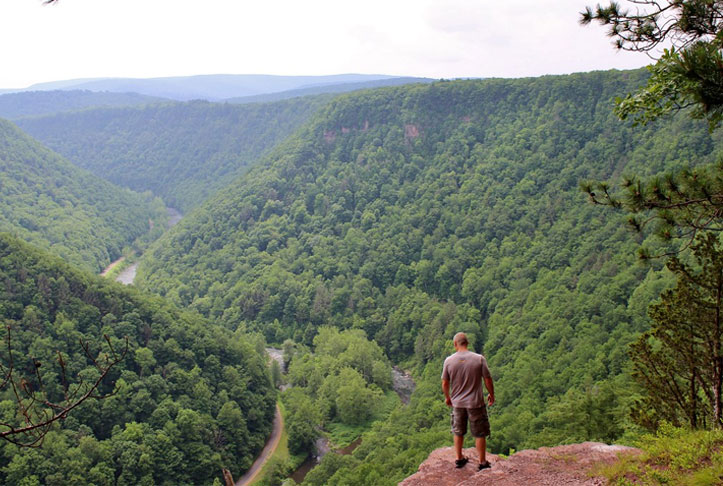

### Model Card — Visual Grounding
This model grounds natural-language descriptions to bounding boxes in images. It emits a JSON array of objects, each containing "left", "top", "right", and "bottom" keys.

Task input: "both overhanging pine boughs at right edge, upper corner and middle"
[{"left": 580, "top": 0, "right": 723, "bottom": 252}]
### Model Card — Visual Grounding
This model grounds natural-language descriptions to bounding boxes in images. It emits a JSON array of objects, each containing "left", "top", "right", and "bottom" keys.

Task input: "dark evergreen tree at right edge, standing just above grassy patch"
[{"left": 631, "top": 233, "right": 723, "bottom": 428}]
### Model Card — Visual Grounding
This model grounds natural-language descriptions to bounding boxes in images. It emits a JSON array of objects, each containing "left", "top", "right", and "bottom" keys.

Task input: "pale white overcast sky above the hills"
[{"left": 0, "top": 0, "right": 651, "bottom": 88}]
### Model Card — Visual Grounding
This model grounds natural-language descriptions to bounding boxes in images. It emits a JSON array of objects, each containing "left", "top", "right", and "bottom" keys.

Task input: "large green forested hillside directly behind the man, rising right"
[{"left": 132, "top": 71, "right": 719, "bottom": 485}]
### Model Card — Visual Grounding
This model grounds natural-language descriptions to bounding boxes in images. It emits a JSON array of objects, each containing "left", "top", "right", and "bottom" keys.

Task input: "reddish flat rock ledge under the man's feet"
[{"left": 399, "top": 442, "right": 640, "bottom": 486}]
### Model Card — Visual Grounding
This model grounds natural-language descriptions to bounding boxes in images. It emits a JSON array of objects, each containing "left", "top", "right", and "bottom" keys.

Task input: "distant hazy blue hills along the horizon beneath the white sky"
[{"left": 2, "top": 74, "right": 430, "bottom": 101}]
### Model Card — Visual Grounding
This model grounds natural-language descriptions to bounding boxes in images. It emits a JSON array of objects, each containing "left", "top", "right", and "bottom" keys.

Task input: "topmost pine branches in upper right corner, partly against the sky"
[{"left": 580, "top": 0, "right": 723, "bottom": 127}]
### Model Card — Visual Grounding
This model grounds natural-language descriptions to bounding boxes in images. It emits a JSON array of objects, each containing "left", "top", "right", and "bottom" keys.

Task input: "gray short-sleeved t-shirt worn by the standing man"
[{"left": 442, "top": 351, "right": 492, "bottom": 408}]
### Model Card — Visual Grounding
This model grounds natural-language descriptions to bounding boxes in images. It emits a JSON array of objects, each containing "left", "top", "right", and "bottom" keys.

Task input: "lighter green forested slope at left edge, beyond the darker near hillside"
[{"left": 0, "top": 120, "right": 166, "bottom": 272}]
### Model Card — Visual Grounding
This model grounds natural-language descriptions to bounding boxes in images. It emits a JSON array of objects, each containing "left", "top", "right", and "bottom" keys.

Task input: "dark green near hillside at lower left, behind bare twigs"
[{"left": 0, "top": 234, "right": 276, "bottom": 486}]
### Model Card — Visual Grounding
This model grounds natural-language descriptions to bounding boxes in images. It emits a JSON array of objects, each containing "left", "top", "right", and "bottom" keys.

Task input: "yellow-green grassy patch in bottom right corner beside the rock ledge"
[{"left": 594, "top": 425, "right": 723, "bottom": 486}]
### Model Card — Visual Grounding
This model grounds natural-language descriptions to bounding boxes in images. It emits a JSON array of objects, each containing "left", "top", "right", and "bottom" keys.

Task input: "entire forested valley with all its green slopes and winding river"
[{"left": 0, "top": 65, "right": 723, "bottom": 486}]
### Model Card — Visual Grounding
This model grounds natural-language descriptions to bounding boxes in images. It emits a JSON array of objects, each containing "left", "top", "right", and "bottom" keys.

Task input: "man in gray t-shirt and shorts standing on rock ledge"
[{"left": 442, "top": 332, "right": 495, "bottom": 471}]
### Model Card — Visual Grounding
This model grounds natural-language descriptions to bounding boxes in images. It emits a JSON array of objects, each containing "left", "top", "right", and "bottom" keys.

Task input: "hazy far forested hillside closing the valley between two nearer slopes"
[{"left": 18, "top": 97, "right": 330, "bottom": 213}]
